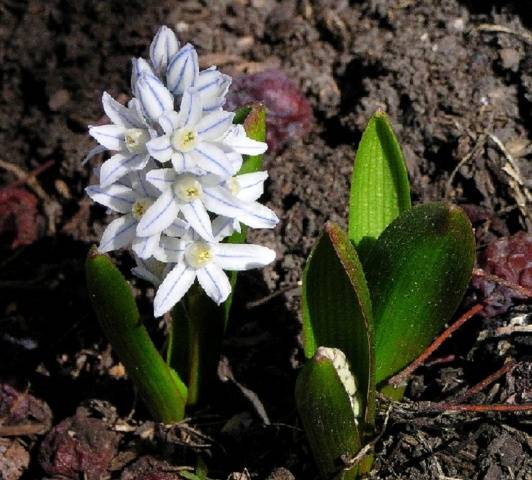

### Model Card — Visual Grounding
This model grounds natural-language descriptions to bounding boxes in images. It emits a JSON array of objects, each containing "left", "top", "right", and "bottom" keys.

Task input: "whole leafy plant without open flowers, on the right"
[{"left": 295, "top": 112, "right": 475, "bottom": 480}]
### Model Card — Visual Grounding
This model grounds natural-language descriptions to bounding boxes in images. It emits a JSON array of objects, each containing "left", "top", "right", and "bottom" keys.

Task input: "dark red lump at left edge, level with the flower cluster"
[{"left": 0, "top": 187, "right": 38, "bottom": 249}]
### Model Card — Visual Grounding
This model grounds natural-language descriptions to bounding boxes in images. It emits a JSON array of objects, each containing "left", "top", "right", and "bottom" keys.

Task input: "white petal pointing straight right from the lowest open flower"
[{"left": 213, "top": 243, "right": 275, "bottom": 270}]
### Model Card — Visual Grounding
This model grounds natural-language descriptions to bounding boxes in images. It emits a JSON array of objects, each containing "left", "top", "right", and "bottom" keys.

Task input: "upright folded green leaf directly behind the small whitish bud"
[{"left": 302, "top": 223, "right": 375, "bottom": 425}]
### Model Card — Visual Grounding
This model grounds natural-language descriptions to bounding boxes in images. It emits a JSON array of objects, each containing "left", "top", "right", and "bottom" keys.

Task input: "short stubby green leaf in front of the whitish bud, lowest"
[{"left": 295, "top": 348, "right": 361, "bottom": 480}]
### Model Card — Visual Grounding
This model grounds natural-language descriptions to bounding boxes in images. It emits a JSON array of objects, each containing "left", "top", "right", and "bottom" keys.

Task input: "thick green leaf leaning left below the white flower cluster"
[{"left": 86, "top": 247, "right": 187, "bottom": 423}]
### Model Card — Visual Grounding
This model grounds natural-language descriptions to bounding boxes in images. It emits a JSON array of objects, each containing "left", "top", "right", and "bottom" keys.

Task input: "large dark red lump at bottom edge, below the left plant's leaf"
[{"left": 39, "top": 408, "right": 119, "bottom": 480}]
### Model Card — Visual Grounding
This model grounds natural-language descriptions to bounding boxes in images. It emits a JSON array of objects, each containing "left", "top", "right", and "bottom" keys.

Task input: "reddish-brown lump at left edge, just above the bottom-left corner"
[{"left": 0, "top": 384, "right": 52, "bottom": 437}]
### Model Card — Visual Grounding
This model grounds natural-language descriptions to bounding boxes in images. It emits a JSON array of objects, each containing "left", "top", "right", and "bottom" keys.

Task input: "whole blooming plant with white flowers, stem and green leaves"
[{"left": 86, "top": 26, "right": 278, "bottom": 423}]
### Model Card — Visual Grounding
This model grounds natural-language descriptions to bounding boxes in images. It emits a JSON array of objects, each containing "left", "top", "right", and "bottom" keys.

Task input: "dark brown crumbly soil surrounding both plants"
[{"left": 0, "top": 0, "right": 532, "bottom": 480}]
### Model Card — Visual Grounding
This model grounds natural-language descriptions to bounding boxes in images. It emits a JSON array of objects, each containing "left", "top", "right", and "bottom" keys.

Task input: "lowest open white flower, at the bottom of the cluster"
[{"left": 153, "top": 234, "right": 275, "bottom": 317}]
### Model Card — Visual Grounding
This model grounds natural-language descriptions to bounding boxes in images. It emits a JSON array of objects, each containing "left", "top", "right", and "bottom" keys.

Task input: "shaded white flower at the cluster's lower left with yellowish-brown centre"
[{"left": 85, "top": 172, "right": 165, "bottom": 259}]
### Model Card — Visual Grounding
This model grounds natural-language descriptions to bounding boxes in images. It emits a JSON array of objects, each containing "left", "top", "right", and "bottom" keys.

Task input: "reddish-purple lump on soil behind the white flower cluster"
[{"left": 226, "top": 70, "right": 313, "bottom": 152}]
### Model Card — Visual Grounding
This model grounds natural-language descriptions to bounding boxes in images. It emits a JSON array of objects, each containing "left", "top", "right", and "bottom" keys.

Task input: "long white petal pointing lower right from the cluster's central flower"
[{"left": 203, "top": 187, "right": 279, "bottom": 228}]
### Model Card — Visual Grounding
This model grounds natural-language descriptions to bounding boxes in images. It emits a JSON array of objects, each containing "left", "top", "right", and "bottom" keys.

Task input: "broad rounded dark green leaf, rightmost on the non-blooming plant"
[{"left": 366, "top": 203, "right": 475, "bottom": 384}]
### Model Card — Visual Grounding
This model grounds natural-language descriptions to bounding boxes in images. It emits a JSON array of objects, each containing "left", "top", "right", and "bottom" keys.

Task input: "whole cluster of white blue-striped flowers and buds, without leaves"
[{"left": 86, "top": 26, "right": 278, "bottom": 316}]
